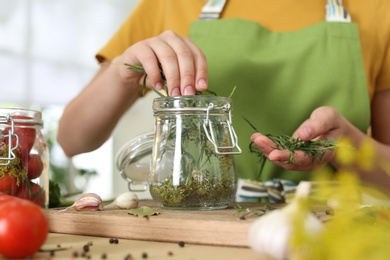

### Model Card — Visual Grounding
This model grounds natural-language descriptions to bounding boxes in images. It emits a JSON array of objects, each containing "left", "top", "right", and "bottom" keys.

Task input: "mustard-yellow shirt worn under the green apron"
[{"left": 97, "top": 0, "right": 390, "bottom": 99}]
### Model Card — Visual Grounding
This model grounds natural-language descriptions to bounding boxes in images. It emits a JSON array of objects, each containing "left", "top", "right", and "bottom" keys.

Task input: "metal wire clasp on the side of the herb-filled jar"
[{"left": 203, "top": 103, "right": 242, "bottom": 154}]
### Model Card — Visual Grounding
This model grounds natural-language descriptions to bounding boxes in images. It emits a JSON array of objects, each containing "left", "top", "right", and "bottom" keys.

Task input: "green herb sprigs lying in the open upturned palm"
[{"left": 244, "top": 118, "right": 336, "bottom": 176}]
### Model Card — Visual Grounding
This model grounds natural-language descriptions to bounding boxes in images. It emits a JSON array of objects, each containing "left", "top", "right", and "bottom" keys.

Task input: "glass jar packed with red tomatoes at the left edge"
[{"left": 0, "top": 108, "right": 49, "bottom": 208}]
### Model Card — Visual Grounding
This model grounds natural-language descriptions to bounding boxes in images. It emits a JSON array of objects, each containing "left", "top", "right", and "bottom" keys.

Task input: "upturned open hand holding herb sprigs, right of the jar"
[{"left": 251, "top": 107, "right": 347, "bottom": 171}]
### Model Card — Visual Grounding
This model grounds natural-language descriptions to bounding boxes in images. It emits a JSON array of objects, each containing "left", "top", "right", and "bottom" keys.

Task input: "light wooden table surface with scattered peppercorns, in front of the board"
[{"left": 32, "top": 233, "right": 267, "bottom": 260}]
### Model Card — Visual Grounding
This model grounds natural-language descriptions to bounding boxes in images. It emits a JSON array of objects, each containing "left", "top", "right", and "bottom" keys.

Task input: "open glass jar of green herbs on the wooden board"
[{"left": 149, "top": 95, "right": 241, "bottom": 210}]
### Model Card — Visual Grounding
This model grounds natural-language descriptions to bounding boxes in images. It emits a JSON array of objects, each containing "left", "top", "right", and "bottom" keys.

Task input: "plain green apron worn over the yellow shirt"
[{"left": 189, "top": 7, "right": 370, "bottom": 185}]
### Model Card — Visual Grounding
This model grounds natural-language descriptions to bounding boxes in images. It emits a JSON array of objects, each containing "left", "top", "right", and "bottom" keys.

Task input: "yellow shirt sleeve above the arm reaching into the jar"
[{"left": 96, "top": 0, "right": 164, "bottom": 62}]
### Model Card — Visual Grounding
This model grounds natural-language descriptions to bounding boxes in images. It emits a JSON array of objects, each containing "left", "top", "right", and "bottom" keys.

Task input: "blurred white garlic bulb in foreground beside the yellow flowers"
[{"left": 248, "top": 182, "right": 323, "bottom": 259}]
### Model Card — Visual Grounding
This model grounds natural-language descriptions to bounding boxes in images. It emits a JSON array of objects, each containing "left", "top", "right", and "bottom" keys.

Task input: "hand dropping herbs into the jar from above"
[{"left": 113, "top": 31, "right": 208, "bottom": 96}]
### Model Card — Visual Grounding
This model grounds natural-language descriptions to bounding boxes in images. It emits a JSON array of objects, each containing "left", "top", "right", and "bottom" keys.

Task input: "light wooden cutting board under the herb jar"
[{"left": 47, "top": 201, "right": 327, "bottom": 247}]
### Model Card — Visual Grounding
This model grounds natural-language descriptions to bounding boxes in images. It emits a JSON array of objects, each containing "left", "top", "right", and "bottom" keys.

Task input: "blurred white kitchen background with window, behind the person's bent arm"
[{"left": 0, "top": 0, "right": 155, "bottom": 199}]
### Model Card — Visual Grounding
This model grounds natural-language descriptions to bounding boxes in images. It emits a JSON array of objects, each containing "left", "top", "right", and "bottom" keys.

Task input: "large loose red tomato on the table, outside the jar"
[{"left": 0, "top": 198, "right": 49, "bottom": 259}]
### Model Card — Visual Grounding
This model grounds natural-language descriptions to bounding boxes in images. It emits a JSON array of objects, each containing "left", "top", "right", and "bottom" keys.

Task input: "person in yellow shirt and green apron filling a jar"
[{"left": 58, "top": 0, "right": 390, "bottom": 197}]
